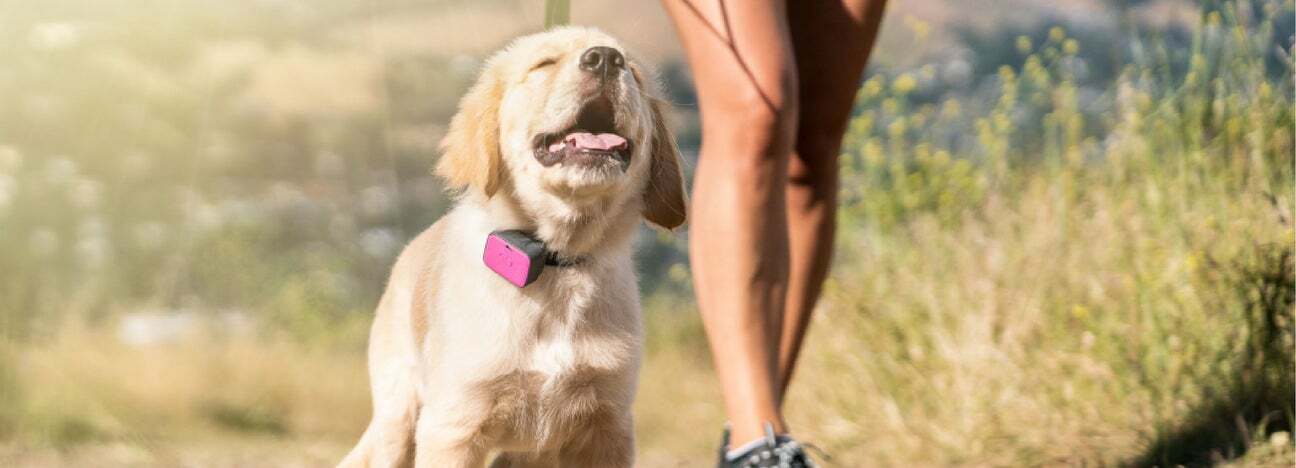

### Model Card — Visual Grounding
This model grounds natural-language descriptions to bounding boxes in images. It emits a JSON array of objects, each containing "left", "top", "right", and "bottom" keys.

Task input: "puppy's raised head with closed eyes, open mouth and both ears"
[{"left": 437, "top": 27, "right": 686, "bottom": 229}]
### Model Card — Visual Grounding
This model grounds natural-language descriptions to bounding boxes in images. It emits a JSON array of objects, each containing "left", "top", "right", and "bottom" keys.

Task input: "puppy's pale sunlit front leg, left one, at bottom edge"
[{"left": 413, "top": 411, "right": 486, "bottom": 468}]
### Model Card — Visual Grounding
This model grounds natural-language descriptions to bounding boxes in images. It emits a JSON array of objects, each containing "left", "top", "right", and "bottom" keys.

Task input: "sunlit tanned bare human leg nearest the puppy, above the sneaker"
[{"left": 664, "top": 0, "right": 797, "bottom": 442}]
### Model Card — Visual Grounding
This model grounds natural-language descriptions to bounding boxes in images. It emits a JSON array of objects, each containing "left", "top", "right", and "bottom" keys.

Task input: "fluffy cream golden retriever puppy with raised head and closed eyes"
[{"left": 341, "top": 27, "right": 686, "bottom": 468}]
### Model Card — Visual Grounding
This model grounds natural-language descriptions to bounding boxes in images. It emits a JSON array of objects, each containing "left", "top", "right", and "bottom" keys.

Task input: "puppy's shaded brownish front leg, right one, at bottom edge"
[{"left": 559, "top": 410, "right": 635, "bottom": 468}]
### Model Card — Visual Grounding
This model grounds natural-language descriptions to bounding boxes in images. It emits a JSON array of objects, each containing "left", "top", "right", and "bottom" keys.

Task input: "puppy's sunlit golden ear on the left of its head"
[{"left": 437, "top": 65, "right": 504, "bottom": 197}]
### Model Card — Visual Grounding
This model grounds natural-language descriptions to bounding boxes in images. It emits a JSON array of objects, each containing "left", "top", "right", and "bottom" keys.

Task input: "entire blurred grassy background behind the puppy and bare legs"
[{"left": 0, "top": 0, "right": 1296, "bottom": 467}]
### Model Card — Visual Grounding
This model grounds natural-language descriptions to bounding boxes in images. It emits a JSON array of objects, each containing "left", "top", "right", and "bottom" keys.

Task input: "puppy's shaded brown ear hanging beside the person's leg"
[{"left": 644, "top": 99, "right": 688, "bottom": 229}]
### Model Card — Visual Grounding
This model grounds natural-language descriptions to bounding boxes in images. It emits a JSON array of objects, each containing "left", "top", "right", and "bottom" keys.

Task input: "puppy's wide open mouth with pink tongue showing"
[{"left": 535, "top": 96, "right": 630, "bottom": 169}]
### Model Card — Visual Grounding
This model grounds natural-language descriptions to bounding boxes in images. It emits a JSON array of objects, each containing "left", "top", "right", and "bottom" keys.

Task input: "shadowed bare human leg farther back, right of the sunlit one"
[{"left": 779, "top": 0, "right": 886, "bottom": 404}]
